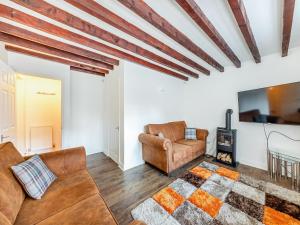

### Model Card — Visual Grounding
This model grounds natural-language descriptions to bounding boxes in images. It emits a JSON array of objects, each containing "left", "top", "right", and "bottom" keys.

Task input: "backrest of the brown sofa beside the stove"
[{"left": 147, "top": 121, "right": 186, "bottom": 142}]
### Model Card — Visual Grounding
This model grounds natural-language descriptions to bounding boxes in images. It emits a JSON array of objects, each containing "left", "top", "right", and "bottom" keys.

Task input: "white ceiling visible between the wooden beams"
[{"left": 0, "top": 0, "right": 300, "bottom": 72}]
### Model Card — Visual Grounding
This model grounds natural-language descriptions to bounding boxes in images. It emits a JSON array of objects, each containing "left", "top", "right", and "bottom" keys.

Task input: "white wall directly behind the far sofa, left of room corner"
[{"left": 124, "top": 62, "right": 186, "bottom": 169}]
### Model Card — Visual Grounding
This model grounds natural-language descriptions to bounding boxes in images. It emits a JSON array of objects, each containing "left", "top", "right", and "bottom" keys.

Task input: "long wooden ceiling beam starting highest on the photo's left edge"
[{"left": 0, "top": 4, "right": 188, "bottom": 81}]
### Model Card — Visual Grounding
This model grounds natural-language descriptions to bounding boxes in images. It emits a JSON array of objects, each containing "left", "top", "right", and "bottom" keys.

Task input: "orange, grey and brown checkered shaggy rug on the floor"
[{"left": 131, "top": 162, "right": 300, "bottom": 225}]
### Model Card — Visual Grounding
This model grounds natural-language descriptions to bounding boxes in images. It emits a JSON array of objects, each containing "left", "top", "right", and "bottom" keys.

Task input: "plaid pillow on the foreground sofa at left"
[{"left": 11, "top": 155, "right": 57, "bottom": 199}]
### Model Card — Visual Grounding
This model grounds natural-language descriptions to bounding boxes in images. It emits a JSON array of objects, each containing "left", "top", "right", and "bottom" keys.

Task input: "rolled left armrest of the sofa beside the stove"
[{"left": 139, "top": 133, "right": 172, "bottom": 150}]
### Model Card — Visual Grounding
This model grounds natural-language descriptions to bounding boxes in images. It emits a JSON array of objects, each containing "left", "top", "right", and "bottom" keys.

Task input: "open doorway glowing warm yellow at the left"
[{"left": 16, "top": 74, "right": 61, "bottom": 155}]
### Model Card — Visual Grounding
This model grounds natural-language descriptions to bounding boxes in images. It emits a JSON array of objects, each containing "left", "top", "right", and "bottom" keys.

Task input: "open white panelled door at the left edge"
[{"left": 0, "top": 61, "right": 16, "bottom": 143}]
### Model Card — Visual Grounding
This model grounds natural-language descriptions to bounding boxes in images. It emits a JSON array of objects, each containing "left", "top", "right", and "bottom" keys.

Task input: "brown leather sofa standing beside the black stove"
[{"left": 139, "top": 121, "right": 208, "bottom": 174}]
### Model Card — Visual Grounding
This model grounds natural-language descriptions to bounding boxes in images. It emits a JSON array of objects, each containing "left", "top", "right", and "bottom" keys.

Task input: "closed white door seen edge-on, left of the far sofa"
[{"left": 108, "top": 74, "right": 120, "bottom": 164}]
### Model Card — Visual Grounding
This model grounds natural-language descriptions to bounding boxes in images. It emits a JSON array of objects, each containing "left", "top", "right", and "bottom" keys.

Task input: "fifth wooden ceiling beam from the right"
[{"left": 65, "top": 0, "right": 209, "bottom": 74}]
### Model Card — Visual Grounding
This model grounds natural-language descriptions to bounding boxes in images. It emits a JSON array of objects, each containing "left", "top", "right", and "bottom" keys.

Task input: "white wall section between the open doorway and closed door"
[{"left": 71, "top": 71, "right": 104, "bottom": 154}]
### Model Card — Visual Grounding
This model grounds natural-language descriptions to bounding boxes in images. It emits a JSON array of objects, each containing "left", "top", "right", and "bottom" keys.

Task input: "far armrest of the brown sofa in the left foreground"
[{"left": 27, "top": 147, "right": 86, "bottom": 177}]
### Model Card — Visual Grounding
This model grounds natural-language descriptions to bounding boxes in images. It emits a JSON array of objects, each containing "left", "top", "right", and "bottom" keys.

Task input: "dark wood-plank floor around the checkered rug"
[{"left": 87, "top": 153, "right": 296, "bottom": 225}]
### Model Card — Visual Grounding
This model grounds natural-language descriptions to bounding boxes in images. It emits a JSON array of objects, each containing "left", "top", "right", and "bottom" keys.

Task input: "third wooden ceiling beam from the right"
[{"left": 176, "top": 0, "right": 241, "bottom": 68}]
